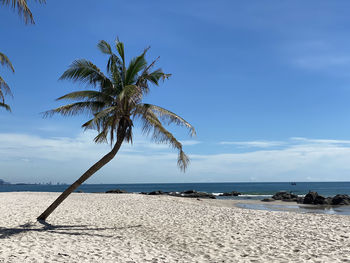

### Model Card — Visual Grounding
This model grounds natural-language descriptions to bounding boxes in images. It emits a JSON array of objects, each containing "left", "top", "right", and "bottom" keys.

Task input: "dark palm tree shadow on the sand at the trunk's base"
[{"left": 0, "top": 221, "right": 142, "bottom": 239}]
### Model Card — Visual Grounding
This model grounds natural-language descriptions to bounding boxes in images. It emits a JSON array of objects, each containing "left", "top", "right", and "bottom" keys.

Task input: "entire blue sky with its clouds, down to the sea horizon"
[{"left": 0, "top": 0, "right": 350, "bottom": 183}]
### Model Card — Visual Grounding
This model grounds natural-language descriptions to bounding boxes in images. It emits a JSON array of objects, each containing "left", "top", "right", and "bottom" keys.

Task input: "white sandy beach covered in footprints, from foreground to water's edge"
[{"left": 0, "top": 193, "right": 350, "bottom": 263}]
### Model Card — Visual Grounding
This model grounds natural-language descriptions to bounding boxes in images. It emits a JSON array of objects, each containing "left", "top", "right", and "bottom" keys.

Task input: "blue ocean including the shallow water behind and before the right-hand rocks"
[{"left": 0, "top": 182, "right": 350, "bottom": 215}]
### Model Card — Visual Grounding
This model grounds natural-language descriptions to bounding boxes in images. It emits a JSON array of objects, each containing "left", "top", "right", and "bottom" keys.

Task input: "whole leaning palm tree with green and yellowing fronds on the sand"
[{"left": 38, "top": 39, "right": 195, "bottom": 220}]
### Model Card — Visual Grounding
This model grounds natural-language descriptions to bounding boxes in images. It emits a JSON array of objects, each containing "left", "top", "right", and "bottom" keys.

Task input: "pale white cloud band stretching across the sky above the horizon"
[{"left": 0, "top": 133, "right": 350, "bottom": 183}]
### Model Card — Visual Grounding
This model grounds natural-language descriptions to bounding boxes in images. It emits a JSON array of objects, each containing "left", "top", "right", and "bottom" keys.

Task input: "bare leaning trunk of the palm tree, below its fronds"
[{"left": 37, "top": 136, "right": 124, "bottom": 221}]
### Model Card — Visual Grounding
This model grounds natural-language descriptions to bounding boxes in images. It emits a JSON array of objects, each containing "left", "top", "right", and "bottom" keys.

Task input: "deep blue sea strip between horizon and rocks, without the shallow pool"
[{"left": 0, "top": 182, "right": 350, "bottom": 199}]
